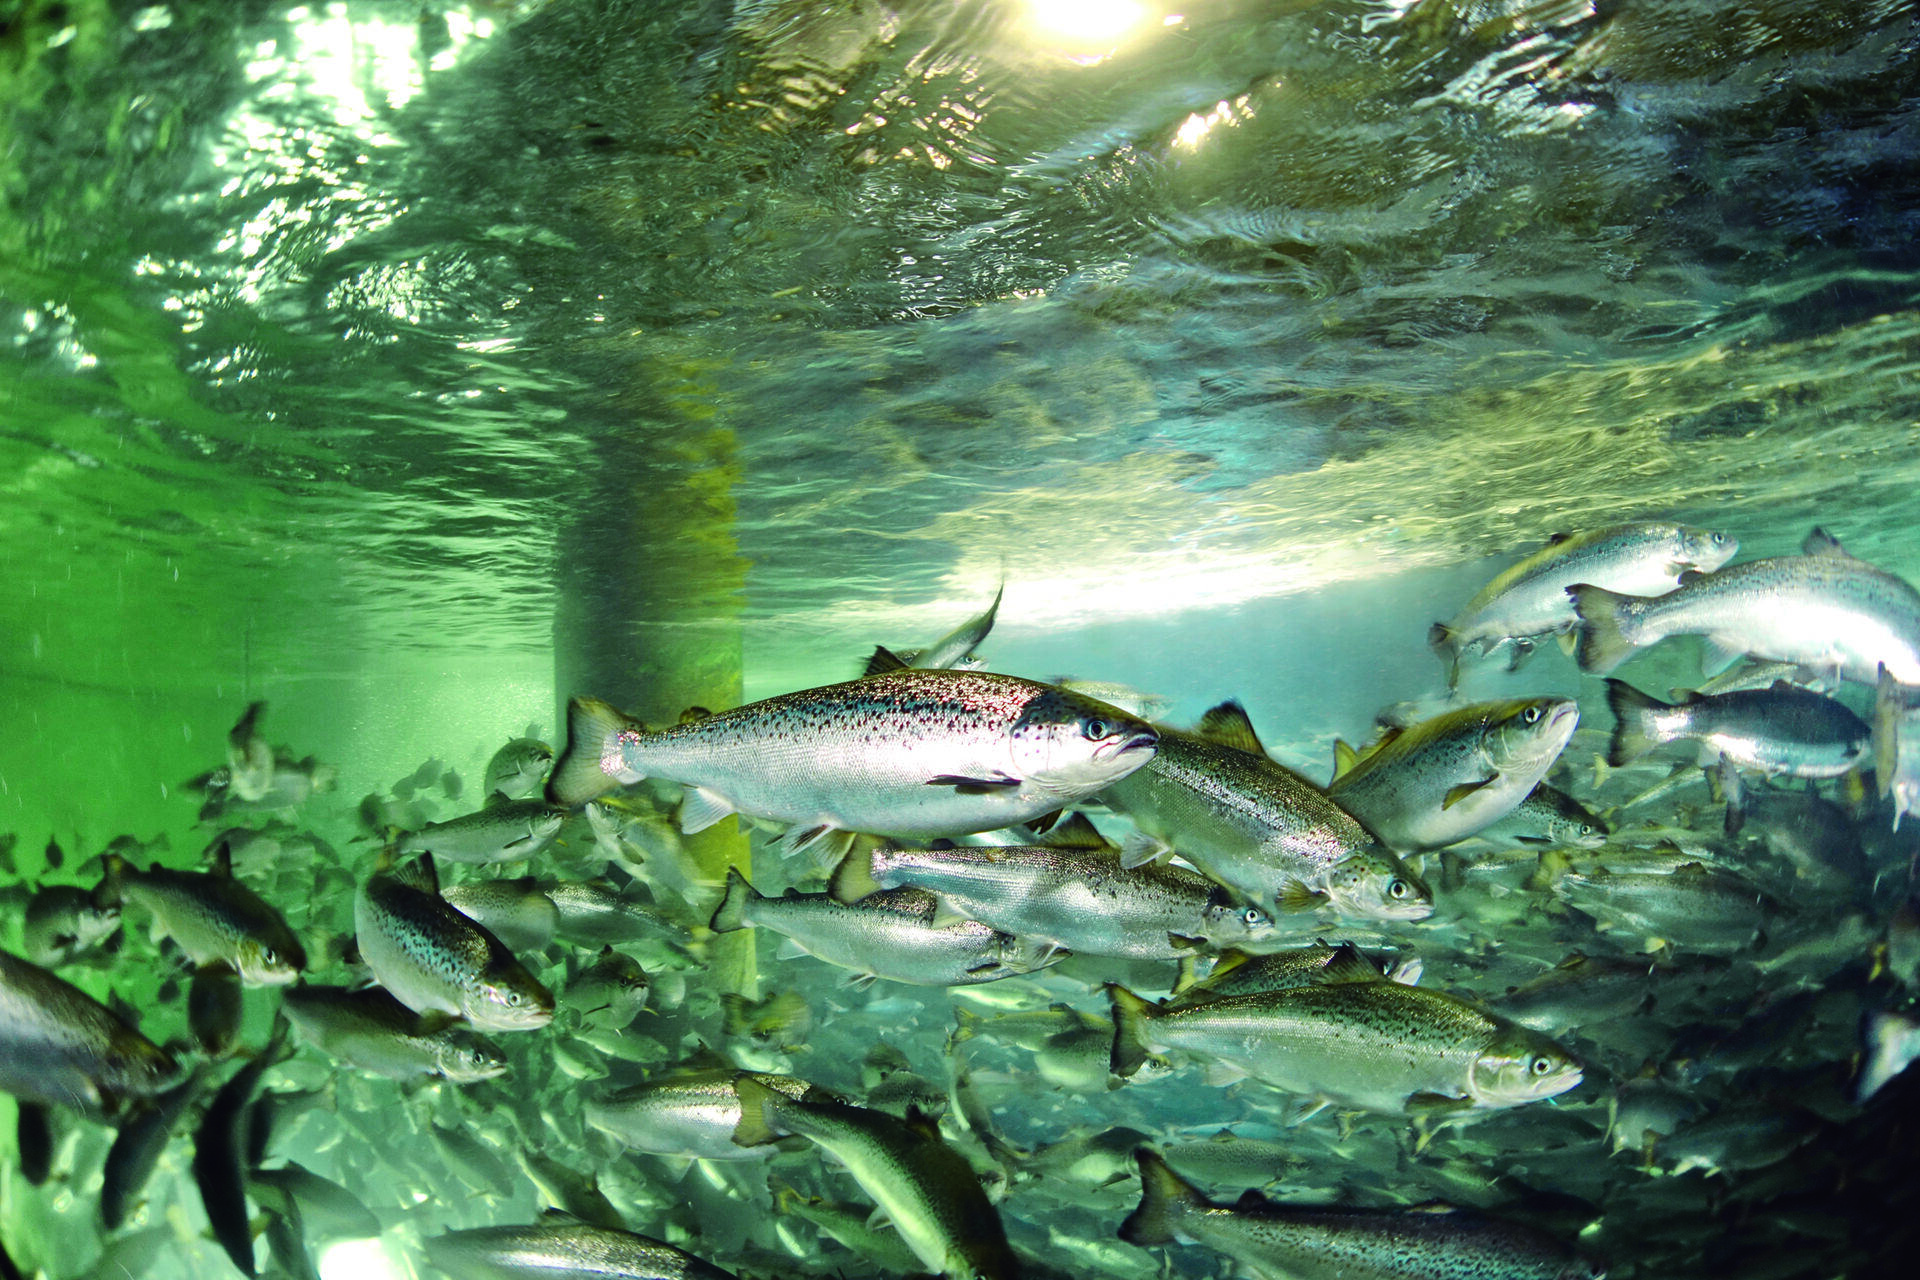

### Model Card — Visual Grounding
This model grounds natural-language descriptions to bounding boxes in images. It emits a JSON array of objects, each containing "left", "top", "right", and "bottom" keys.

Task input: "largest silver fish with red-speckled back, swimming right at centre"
[{"left": 549, "top": 670, "right": 1158, "bottom": 852}]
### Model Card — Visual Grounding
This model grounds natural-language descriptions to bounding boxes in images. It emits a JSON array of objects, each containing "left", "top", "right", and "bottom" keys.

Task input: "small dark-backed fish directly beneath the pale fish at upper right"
[{"left": 1607, "top": 679, "right": 1870, "bottom": 777}]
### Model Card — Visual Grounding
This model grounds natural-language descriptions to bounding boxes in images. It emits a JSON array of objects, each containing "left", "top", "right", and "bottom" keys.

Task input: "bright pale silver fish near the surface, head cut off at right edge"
[{"left": 1567, "top": 530, "right": 1920, "bottom": 685}]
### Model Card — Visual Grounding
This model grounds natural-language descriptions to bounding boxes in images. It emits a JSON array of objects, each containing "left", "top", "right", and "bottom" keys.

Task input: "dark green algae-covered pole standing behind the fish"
[{"left": 553, "top": 416, "right": 755, "bottom": 996}]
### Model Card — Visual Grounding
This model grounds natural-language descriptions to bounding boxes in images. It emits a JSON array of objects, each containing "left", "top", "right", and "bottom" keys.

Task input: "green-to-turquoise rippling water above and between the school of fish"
[{"left": 0, "top": 0, "right": 1920, "bottom": 1280}]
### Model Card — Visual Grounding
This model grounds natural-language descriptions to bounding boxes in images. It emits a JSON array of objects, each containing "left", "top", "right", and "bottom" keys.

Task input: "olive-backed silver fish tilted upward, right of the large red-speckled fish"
[{"left": 1327, "top": 699, "right": 1580, "bottom": 852}]
